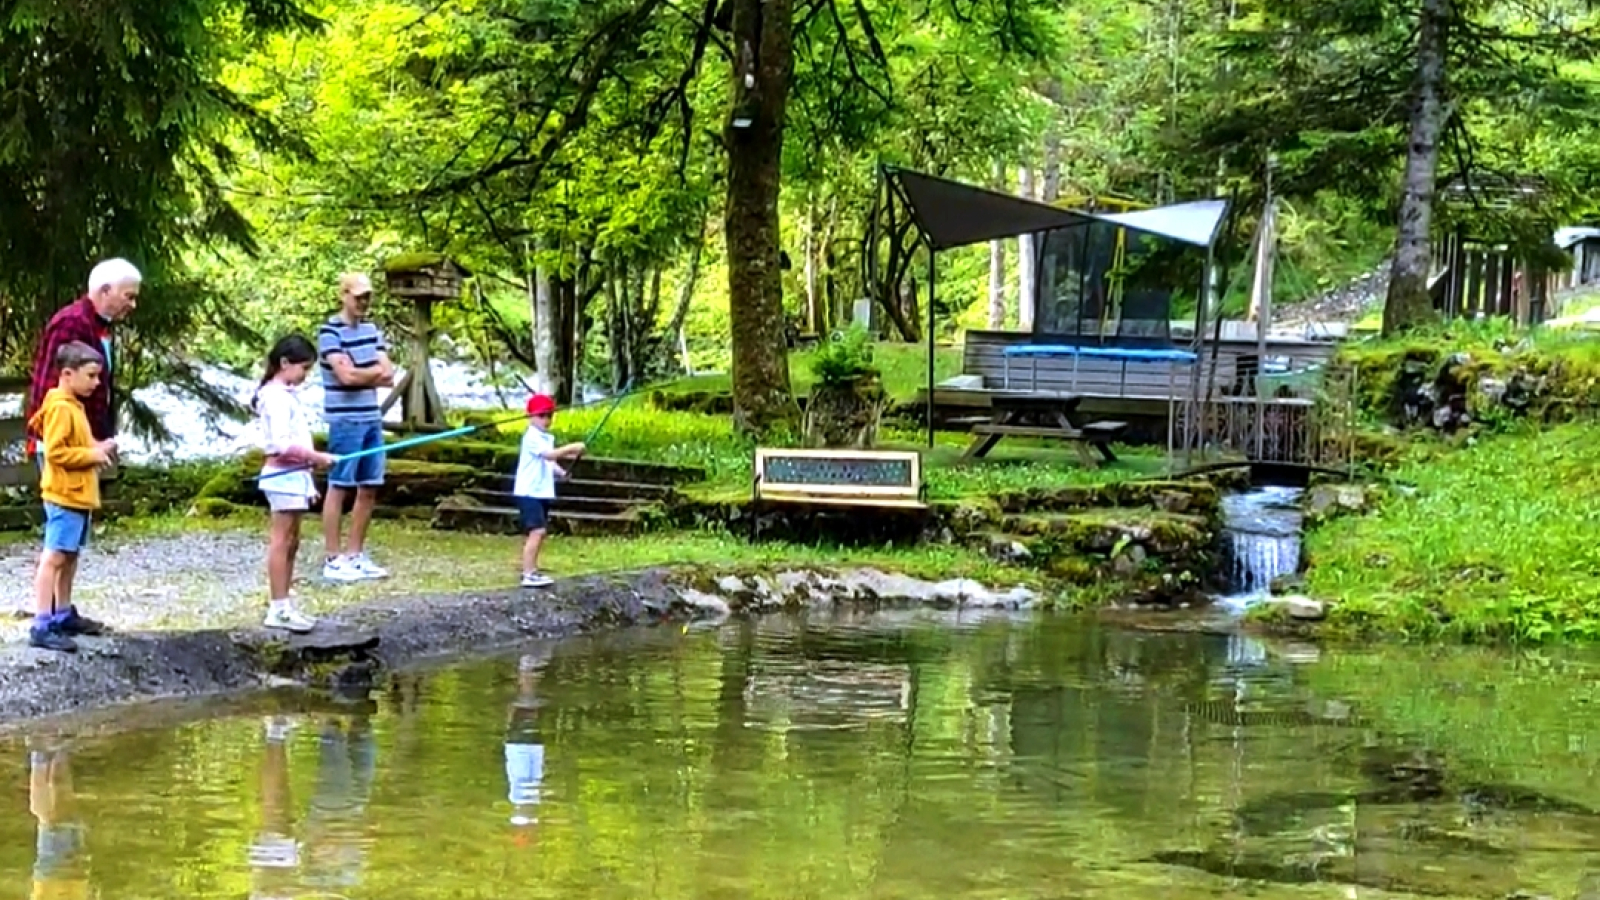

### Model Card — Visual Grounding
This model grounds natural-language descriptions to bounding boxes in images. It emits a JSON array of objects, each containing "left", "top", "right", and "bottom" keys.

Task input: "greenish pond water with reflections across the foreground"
[{"left": 0, "top": 613, "right": 1600, "bottom": 900}]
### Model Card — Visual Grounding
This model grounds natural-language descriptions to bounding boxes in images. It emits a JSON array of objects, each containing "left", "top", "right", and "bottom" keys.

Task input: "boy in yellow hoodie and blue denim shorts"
[{"left": 29, "top": 341, "right": 117, "bottom": 653}]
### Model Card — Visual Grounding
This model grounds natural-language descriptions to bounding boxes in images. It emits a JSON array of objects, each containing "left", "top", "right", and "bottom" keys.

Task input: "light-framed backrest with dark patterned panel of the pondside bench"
[{"left": 755, "top": 447, "right": 922, "bottom": 500}]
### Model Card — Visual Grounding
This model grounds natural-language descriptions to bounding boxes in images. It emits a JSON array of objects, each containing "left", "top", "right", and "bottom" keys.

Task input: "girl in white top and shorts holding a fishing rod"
[{"left": 251, "top": 335, "right": 334, "bottom": 633}]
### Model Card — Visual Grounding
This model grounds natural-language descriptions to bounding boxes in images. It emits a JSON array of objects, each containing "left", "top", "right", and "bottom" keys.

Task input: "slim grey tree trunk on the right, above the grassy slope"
[{"left": 1384, "top": 0, "right": 1450, "bottom": 335}]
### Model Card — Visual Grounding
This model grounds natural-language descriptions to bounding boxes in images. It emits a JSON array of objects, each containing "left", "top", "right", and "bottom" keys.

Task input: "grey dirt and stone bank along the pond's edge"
[{"left": 0, "top": 569, "right": 1037, "bottom": 729}]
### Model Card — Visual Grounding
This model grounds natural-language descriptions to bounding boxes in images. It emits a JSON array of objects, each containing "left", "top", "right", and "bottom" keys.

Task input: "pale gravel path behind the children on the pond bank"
[{"left": 0, "top": 530, "right": 366, "bottom": 641}]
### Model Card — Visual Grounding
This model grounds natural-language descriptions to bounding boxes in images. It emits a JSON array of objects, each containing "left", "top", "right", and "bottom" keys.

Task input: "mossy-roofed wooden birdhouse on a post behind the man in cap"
[{"left": 384, "top": 253, "right": 472, "bottom": 431}]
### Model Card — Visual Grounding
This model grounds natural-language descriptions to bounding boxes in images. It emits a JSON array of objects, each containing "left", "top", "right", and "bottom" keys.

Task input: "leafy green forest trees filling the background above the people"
[{"left": 0, "top": 0, "right": 1600, "bottom": 431}]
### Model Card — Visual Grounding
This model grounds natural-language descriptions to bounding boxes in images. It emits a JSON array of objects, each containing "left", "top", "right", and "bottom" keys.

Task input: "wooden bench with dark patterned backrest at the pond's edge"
[{"left": 750, "top": 447, "right": 928, "bottom": 540}]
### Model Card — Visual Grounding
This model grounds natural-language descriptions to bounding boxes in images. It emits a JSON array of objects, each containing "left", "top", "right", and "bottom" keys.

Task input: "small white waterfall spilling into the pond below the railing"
[{"left": 1221, "top": 487, "right": 1302, "bottom": 609}]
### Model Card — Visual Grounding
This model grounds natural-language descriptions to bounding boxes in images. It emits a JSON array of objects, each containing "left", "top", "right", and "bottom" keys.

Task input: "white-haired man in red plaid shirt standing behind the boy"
[{"left": 24, "top": 259, "right": 144, "bottom": 634}]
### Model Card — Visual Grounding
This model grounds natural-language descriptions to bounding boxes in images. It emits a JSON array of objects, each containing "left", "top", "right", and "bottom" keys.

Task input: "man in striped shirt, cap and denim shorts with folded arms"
[{"left": 317, "top": 272, "right": 395, "bottom": 581}]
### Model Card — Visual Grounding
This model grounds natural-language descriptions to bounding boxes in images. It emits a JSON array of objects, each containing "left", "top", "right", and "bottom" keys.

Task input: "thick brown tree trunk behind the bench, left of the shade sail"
[{"left": 725, "top": 0, "right": 800, "bottom": 436}]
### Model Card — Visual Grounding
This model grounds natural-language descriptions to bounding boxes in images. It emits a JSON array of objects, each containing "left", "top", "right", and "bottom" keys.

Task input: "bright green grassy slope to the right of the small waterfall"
[{"left": 1307, "top": 424, "right": 1600, "bottom": 642}]
